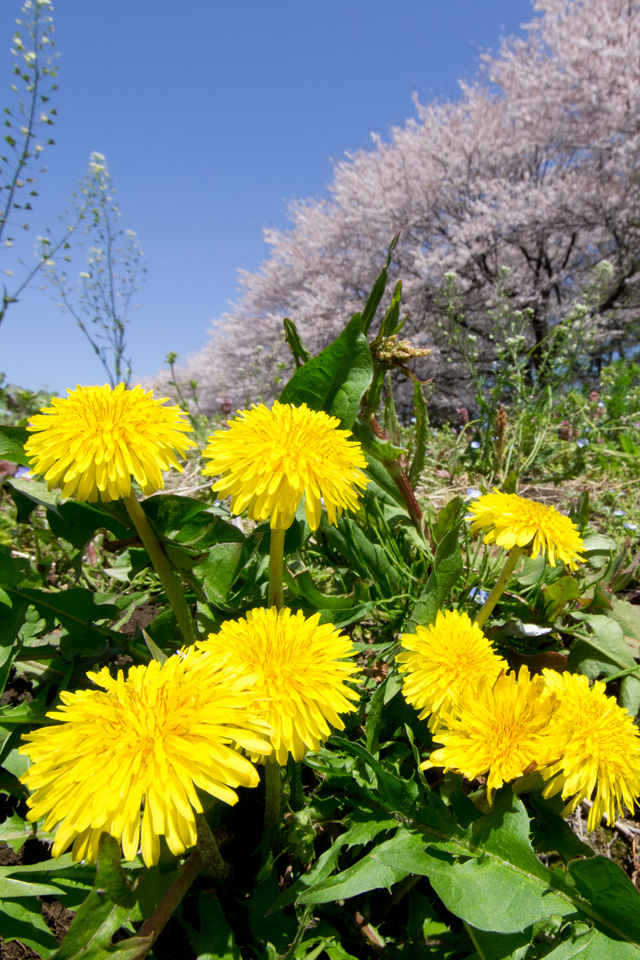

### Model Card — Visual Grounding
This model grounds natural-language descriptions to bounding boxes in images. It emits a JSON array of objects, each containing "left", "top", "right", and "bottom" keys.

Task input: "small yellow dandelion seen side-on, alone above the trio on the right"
[{"left": 469, "top": 488, "right": 585, "bottom": 570}]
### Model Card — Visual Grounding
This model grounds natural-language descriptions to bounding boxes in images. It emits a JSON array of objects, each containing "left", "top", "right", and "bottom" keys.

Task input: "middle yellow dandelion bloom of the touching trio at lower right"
[{"left": 428, "top": 667, "right": 556, "bottom": 803}]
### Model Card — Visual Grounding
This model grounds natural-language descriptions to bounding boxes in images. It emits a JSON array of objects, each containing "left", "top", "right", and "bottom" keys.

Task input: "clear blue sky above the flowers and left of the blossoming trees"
[{"left": 0, "top": 0, "right": 533, "bottom": 393}]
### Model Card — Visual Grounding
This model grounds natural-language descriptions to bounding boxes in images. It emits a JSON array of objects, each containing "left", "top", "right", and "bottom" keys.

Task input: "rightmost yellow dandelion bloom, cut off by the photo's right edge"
[{"left": 542, "top": 670, "right": 640, "bottom": 830}]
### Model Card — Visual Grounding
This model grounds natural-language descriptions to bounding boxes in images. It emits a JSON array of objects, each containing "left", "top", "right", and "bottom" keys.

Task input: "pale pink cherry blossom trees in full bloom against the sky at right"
[{"left": 166, "top": 0, "right": 640, "bottom": 420}]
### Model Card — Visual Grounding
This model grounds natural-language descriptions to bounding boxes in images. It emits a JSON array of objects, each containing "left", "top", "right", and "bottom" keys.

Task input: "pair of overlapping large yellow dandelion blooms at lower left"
[{"left": 20, "top": 608, "right": 358, "bottom": 866}]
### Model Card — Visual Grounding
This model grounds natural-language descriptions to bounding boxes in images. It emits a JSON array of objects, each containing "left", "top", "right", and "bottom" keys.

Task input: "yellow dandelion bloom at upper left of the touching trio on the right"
[{"left": 396, "top": 610, "right": 508, "bottom": 730}]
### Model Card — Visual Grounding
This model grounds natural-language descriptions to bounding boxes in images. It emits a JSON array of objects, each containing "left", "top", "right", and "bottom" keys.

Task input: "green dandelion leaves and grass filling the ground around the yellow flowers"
[{"left": 0, "top": 244, "right": 640, "bottom": 960}]
